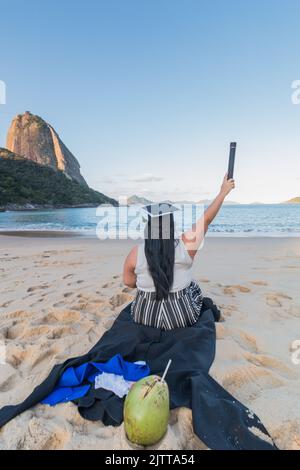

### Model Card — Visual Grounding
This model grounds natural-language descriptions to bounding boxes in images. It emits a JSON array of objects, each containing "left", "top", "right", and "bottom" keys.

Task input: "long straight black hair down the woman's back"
[{"left": 145, "top": 214, "right": 178, "bottom": 300}]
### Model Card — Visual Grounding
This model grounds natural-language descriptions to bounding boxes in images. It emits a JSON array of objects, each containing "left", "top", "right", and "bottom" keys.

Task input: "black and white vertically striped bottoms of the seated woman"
[{"left": 131, "top": 281, "right": 203, "bottom": 330}]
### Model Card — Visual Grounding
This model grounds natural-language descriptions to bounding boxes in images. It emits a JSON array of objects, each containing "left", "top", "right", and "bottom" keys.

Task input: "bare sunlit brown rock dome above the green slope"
[{"left": 6, "top": 111, "right": 87, "bottom": 186}]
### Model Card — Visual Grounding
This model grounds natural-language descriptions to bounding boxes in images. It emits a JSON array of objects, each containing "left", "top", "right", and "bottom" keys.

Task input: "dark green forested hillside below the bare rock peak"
[{"left": 0, "top": 149, "right": 117, "bottom": 207}]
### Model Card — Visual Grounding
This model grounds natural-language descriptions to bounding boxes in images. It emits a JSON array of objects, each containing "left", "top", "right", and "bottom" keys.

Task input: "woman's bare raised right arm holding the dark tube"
[{"left": 182, "top": 173, "right": 235, "bottom": 258}]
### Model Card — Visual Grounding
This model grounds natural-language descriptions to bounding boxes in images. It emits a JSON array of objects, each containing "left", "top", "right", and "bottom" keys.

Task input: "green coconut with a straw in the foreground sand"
[{"left": 124, "top": 375, "right": 170, "bottom": 446}]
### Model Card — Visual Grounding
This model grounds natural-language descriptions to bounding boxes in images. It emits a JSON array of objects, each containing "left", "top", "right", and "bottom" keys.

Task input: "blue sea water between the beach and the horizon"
[{"left": 0, "top": 204, "right": 300, "bottom": 238}]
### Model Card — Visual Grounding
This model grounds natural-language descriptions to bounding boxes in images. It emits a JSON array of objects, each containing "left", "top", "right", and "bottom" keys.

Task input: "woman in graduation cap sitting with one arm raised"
[{"left": 123, "top": 174, "right": 235, "bottom": 330}]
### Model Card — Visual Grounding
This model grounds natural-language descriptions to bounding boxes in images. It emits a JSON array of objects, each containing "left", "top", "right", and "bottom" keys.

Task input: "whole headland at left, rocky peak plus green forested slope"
[{"left": 0, "top": 111, "right": 118, "bottom": 211}]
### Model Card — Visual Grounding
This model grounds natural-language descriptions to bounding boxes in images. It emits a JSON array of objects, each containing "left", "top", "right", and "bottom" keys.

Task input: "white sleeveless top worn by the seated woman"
[{"left": 134, "top": 238, "right": 193, "bottom": 292}]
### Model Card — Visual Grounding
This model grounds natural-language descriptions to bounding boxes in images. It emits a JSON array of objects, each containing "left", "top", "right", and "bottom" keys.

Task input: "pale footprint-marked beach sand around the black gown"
[{"left": 0, "top": 233, "right": 300, "bottom": 450}]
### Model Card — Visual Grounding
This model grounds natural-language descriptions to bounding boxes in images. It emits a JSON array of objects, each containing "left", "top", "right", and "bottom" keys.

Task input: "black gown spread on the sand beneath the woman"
[{"left": 0, "top": 298, "right": 277, "bottom": 450}]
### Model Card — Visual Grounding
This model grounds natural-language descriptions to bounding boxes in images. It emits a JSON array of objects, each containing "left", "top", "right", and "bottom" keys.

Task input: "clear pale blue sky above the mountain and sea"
[{"left": 0, "top": 0, "right": 300, "bottom": 202}]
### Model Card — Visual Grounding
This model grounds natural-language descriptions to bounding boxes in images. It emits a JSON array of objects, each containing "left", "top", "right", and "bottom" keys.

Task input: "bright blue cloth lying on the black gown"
[{"left": 41, "top": 354, "right": 150, "bottom": 406}]
